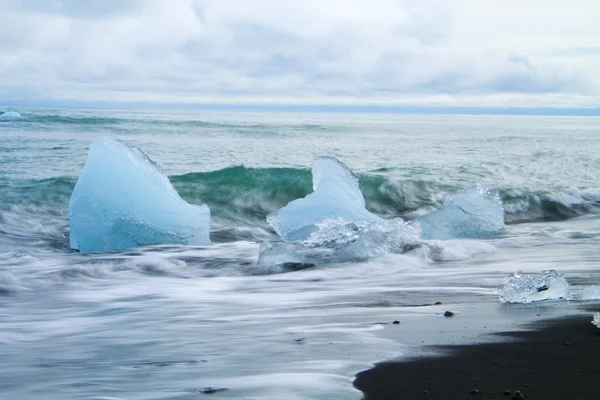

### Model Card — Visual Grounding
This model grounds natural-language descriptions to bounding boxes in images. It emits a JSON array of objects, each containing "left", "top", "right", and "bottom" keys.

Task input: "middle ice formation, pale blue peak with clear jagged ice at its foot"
[{"left": 258, "top": 157, "right": 418, "bottom": 273}]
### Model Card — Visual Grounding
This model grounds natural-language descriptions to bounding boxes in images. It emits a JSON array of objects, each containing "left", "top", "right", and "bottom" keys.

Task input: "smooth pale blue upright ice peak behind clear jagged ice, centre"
[{"left": 267, "top": 157, "right": 381, "bottom": 242}]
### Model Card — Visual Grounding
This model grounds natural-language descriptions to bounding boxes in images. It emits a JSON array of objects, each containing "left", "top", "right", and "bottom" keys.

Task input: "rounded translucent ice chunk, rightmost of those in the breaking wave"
[{"left": 418, "top": 187, "right": 504, "bottom": 240}]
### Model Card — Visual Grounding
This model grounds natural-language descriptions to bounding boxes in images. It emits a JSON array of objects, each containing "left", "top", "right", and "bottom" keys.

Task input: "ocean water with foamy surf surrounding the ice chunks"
[{"left": 0, "top": 108, "right": 600, "bottom": 399}]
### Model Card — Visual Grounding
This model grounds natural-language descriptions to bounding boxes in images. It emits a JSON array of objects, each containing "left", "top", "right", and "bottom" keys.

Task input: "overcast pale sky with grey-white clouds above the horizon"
[{"left": 0, "top": 0, "right": 600, "bottom": 107}]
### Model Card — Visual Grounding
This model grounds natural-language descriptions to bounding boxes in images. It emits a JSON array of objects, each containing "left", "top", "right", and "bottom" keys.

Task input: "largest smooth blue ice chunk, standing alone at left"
[{"left": 69, "top": 137, "right": 210, "bottom": 252}]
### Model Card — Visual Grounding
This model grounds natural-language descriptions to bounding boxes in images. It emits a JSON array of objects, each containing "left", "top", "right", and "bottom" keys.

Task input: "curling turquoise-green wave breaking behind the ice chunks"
[{"left": 0, "top": 166, "right": 600, "bottom": 227}]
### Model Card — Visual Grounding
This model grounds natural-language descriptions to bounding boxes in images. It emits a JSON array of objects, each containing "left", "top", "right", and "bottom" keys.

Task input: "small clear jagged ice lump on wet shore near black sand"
[{"left": 498, "top": 270, "right": 569, "bottom": 303}]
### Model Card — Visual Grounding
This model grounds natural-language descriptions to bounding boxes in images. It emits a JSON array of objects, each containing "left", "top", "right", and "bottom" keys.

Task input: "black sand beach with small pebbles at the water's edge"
[{"left": 354, "top": 312, "right": 600, "bottom": 400}]
